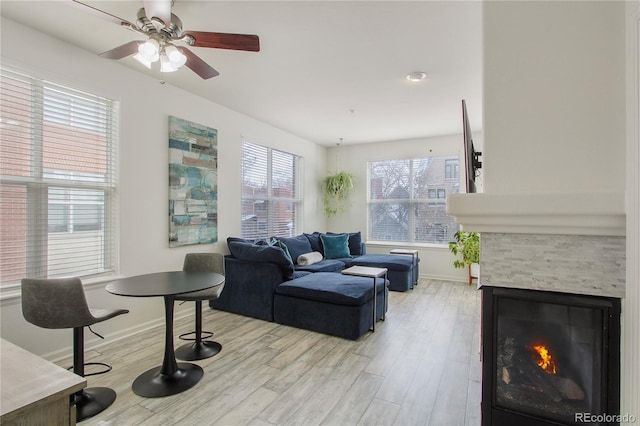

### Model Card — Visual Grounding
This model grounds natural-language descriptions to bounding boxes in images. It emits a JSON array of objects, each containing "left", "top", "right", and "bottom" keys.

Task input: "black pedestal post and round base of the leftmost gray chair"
[{"left": 72, "top": 327, "right": 116, "bottom": 422}]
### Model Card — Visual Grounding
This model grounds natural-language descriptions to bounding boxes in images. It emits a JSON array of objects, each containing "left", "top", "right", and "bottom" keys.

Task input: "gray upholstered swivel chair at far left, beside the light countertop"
[{"left": 22, "top": 278, "right": 129, "bottom": 421}]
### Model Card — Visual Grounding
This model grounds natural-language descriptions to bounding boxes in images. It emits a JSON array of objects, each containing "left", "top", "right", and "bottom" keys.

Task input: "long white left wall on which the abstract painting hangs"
[{"left": 0, "top": 18, "right": 326, "bottom": 359}]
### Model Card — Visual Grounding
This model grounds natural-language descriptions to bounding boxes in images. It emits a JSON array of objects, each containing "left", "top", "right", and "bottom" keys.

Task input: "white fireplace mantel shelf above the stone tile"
[{"left": 447, "top": 192, "right": 626, "bottom": 236}]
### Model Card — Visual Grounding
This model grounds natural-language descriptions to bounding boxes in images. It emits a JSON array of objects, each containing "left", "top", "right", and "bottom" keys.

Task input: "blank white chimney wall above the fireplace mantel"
[{"left": 483, "top": 1, "right": 625, "bottom": 193}]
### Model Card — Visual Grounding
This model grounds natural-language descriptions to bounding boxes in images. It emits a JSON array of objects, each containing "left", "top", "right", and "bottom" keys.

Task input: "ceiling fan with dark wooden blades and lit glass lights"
[{"left": 73, "top": 0, "right": 260, "bottom": 79}]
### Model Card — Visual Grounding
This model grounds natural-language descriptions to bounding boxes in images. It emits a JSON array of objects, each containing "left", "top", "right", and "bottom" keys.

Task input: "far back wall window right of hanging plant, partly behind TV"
[{"left": 368, "top": 156, "right": 459, "bottom": 244}]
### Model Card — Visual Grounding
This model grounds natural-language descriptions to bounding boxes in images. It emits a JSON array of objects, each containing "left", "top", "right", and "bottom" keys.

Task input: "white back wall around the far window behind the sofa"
[{"left": 325, "top": 134, "right": 482, "bottom": 281}]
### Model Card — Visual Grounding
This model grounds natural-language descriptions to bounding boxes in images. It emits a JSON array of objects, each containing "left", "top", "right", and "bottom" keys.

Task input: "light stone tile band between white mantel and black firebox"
[{"left": 480, "top": 232, "right": 626, "bottom": 298}]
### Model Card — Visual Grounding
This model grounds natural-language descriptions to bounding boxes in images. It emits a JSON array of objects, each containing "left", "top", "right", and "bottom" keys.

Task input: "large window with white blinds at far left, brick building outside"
[{"left": 0, "top": 68, "right": 119, "bottom": 287}]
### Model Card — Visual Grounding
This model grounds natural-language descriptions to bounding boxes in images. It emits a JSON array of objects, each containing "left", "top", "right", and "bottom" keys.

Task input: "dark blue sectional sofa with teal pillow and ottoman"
[{"left": 209, "top": 232, "right": 417, "bottom": 340}]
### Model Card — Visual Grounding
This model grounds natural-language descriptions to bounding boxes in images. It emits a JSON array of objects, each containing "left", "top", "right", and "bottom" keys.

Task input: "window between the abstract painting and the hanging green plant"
[{"left": 241, "top": 142, "right": 302, "bottom": 238}]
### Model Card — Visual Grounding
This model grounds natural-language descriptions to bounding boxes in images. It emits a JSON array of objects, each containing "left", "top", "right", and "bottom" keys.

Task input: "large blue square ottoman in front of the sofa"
[{"left": 273, "top": 272, "right": 388, "bottom": 340}]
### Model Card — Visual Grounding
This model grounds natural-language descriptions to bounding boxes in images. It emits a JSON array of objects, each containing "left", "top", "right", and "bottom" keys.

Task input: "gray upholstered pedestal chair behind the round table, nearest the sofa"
[{"left": 175, "top": 253, "right": 224, "bottom": 361}]
